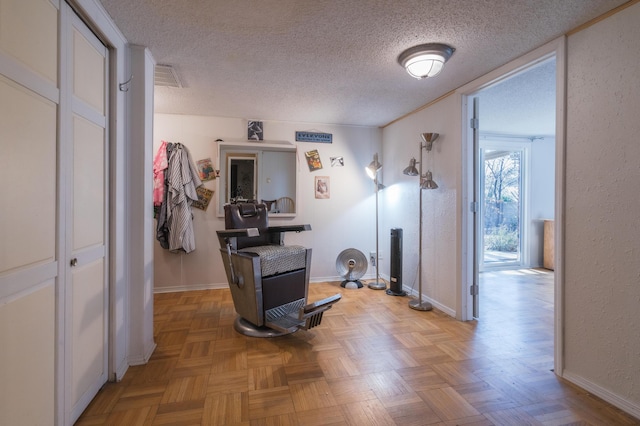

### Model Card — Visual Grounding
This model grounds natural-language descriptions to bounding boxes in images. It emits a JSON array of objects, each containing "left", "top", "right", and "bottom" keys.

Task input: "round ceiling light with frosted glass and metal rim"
[{"left": 398, "top": 43, "right": 455, "bottom": 79}]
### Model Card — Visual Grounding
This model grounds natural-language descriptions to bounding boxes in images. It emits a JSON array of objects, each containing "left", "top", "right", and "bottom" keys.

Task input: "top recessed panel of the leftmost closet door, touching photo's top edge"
[{"left": 0, "top": 0, "right": 58, "bottom": 86}]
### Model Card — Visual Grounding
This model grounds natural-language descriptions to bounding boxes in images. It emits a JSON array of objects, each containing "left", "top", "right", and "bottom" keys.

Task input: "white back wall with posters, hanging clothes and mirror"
[{"left": 153, "top": 114, "right": 388, "bottom": 292}]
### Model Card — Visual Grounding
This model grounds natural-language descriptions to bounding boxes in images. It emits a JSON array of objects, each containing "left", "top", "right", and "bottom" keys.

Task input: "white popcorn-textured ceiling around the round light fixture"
[{"left": 101, "top": 0, "right": 625, "bottom": 133}]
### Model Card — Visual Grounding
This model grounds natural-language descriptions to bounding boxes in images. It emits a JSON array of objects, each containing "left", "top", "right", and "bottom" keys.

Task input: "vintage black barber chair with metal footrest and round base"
[{"left": 217, "top": 203, "right": 341, "bottom": 337}]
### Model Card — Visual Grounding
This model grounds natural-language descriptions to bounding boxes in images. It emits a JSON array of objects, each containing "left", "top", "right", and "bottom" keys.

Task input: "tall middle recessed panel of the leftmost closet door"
[{"left": 0, "top": 76, "right": 57, "bottom": 273}]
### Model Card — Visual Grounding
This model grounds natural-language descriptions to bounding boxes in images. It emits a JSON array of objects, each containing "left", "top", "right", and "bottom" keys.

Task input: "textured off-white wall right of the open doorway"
[{"left": 564, "top": 4, "right": 640, "bottom": 416}]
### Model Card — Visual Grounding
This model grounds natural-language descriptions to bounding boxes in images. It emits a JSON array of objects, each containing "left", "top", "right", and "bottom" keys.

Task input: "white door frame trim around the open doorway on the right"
[{"left": 456, "top": 36, "right": 567, "bottom": 376}]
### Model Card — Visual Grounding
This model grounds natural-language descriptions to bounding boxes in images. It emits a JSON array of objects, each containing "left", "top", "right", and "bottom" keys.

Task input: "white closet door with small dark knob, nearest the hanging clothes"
[{"left": 61, "top": 4, "right": 109, "bottom": 421}]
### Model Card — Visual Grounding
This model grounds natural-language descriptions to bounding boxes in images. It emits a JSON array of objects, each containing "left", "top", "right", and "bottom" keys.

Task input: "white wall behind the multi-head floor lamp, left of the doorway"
[{"left": 380, "top": 96, "right": 461, "bottom": 316}]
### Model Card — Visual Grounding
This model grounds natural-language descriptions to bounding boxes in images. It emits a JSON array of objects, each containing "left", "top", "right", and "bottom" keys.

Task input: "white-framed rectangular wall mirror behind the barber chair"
[{"left": 216, "top": 142, "right": 298, "bottom": 217}]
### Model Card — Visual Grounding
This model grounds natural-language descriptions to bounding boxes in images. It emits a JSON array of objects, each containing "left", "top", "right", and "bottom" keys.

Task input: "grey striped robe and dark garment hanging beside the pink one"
[{"left": 154, "top": 143, "right": 202, "bottom": 253}]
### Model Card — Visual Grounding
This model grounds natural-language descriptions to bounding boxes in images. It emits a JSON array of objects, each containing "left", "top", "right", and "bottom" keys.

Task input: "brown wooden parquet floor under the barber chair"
[{"left": 76, "top": 271, "right": 640, "bottom": 426}]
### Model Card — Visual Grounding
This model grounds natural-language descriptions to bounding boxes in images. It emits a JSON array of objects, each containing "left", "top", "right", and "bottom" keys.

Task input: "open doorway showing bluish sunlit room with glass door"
[{"left": 463, "top": 40, "right": 564, "bottom": 369}]
